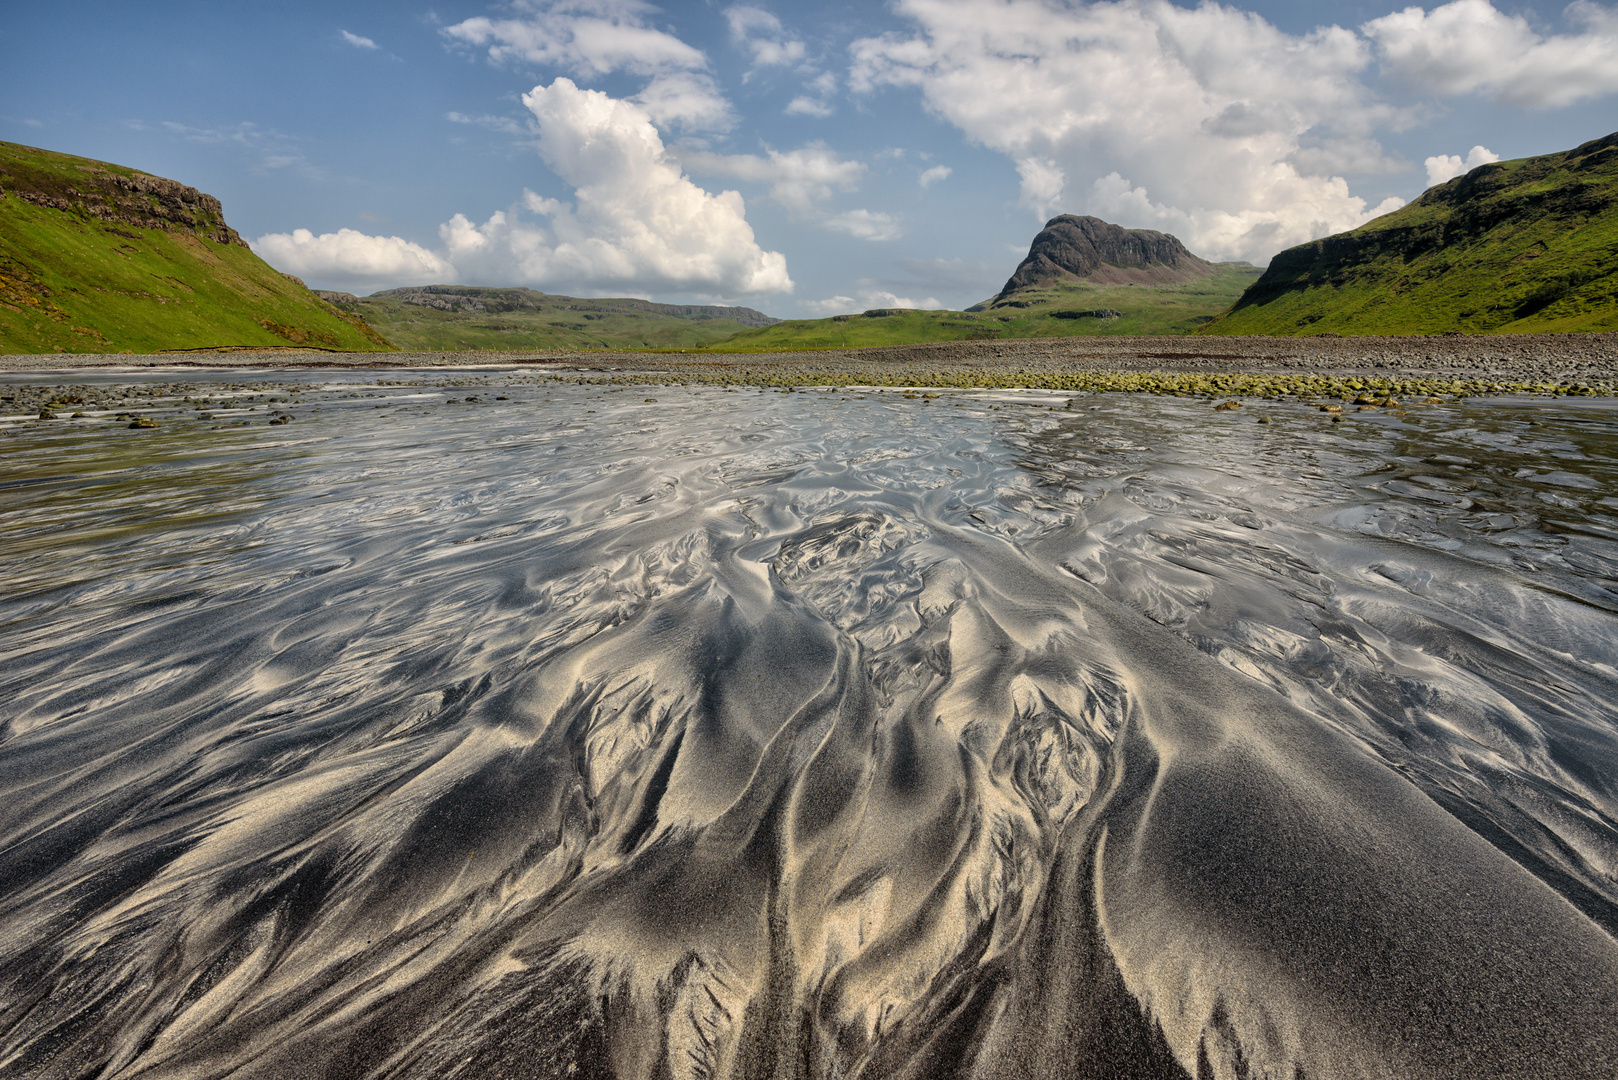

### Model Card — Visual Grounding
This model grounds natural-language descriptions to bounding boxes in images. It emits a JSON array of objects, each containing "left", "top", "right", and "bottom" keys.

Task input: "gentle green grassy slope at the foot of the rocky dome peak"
[{"left": 705, "top": 262, "right": 1259, "bottom": 353}]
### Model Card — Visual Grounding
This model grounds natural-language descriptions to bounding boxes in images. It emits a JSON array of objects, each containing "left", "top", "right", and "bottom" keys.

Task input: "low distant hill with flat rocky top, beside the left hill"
[{"left": 331, "top": 285, "right": 775, "bottom": 351}]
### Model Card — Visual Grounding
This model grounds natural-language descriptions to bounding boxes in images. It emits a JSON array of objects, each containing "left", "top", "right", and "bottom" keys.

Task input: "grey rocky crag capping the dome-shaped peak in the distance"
[{"left": 1000, "top": 214, "right": 1214, "bottom": 296}]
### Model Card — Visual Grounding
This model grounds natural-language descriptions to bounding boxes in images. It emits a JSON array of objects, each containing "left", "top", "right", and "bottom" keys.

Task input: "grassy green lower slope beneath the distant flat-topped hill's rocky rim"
[{"left": 343, "top": 293, "right": 763, "bottom": 351}]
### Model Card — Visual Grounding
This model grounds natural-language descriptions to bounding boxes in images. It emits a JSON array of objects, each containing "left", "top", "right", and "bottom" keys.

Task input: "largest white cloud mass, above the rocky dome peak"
[{"left": 851, "top": 0, "right": 1396, "bottom": 261}]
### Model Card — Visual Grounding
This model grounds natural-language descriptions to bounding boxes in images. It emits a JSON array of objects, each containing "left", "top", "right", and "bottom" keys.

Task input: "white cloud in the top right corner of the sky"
[{"left": 1361, "top": 0, "right": 1618, "bottom": 108}]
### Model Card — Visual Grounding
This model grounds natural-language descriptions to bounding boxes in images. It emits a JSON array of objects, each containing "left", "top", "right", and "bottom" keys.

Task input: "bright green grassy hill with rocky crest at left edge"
[{"left": 0, "top": 142, "right": 393, "bottom": 353}]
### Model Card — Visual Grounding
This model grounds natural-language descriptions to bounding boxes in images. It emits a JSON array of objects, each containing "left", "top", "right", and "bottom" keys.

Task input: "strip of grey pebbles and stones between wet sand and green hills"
[{"left": 9, "top": 334, "right": 1618, "bottom": 382}]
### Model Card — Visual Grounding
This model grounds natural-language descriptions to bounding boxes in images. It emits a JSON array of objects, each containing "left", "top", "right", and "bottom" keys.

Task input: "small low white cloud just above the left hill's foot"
[{"left": 252, "top": 228, "right": 456, "bottom": 291}]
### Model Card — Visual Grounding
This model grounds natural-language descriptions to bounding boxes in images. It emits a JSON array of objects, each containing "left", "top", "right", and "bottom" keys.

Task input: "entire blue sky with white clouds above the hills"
[{"left": 0, "top": 0, "right": 1618, "bottom": 317}]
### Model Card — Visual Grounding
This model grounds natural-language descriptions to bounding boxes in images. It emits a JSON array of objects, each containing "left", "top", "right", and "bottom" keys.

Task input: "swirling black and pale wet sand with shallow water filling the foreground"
[{"left": 0, "top": 371, "right": 1618, "bottom": 1078}]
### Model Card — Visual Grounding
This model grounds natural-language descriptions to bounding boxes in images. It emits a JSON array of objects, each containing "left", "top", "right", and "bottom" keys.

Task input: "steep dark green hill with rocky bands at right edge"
[{"left": 1202, "top": 134, "right": 1618, "bottom": 335}]
